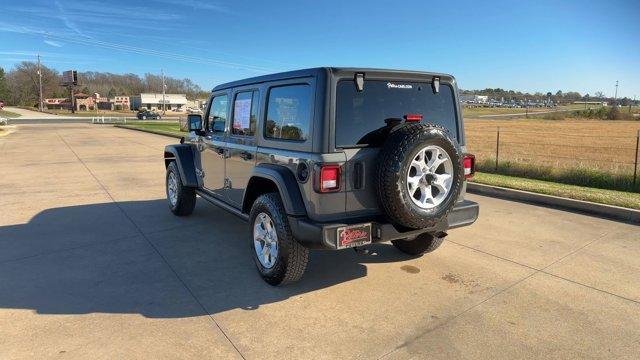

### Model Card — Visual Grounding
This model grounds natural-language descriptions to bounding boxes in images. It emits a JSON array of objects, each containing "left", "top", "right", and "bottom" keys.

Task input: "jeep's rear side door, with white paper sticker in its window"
[{"left": 225, "top": 88, "right": 260, "bottom": 207}]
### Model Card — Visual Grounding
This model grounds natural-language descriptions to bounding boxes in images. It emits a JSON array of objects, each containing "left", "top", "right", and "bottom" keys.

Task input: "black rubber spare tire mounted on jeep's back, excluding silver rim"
[{"left": 377, "top": 124, "right": 464, "bottom": 229}]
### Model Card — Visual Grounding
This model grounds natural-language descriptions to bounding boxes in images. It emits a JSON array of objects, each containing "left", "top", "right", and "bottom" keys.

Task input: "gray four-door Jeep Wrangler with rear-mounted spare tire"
[{"left": 164, "top": 68, "right": 478, "bottom": 285}]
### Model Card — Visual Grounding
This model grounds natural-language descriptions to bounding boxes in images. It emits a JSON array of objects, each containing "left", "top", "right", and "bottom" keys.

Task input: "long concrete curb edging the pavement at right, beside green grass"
[{"left": 467, "top": 182, "right": 640, "bottom": 224}]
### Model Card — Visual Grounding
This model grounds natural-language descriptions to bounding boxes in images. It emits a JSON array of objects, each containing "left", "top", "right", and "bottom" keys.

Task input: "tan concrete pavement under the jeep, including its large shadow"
[{"left": 0, "top": 124, "right": 640, "bottom": 359}]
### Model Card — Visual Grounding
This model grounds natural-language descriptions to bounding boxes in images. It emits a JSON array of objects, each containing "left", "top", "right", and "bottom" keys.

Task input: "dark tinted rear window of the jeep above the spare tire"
[{"left": 336, "top": 80, "right": 458, "bottom": 147}]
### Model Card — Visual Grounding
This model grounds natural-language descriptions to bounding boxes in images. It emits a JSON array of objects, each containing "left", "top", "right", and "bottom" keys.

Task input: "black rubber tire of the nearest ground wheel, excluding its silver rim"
[{"left": 249, "top": 193, "right": 309, "bottom": 286}]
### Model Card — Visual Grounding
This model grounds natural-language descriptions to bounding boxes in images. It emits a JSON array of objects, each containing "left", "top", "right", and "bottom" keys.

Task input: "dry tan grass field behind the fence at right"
[{"left": 465, "top": 119, "right": 640, "bottom": 174}]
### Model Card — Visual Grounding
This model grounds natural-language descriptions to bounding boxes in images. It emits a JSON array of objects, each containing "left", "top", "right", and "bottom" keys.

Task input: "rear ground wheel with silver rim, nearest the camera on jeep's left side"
[{"left": 249, "top": 193, "right": 309, "bottom": 286}]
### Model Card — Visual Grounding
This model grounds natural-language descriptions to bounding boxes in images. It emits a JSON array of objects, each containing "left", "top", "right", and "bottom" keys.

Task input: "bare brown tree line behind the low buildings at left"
[{"left": 0, "top": 61, "right": 208, "bottom": 106}]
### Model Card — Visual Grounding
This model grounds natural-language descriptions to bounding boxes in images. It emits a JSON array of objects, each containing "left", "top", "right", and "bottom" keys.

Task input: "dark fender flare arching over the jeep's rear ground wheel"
[{"left": 242, "top": 164, "right": 307, "bottom": 216}]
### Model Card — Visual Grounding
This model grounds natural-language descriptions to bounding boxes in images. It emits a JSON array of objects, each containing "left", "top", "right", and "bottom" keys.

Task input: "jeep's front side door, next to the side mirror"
[{"left": 198, "top": 92, "right": 229, "bottom": 196}]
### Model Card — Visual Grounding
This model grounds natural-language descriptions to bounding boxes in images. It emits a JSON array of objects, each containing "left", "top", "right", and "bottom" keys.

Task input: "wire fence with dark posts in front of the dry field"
[{"left": 466, "top": 126, "right": 640, "bottom": 186}]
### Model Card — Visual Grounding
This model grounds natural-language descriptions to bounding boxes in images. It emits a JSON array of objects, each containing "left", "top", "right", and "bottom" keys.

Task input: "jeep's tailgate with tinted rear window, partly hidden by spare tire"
[{"left": 335, "top": 80, "right": 458, "bottom": 216}]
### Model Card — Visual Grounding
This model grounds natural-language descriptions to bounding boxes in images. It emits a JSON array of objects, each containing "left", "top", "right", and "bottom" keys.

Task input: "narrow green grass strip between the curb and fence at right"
[{"left": 472, "top": 173, "right": 640, "bottom": 209}]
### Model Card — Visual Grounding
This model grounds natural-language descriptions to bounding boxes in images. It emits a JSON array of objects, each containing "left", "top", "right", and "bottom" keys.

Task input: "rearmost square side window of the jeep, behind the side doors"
[{"left": 265, "top": 85, "right": 311, "bottom": 141}]
